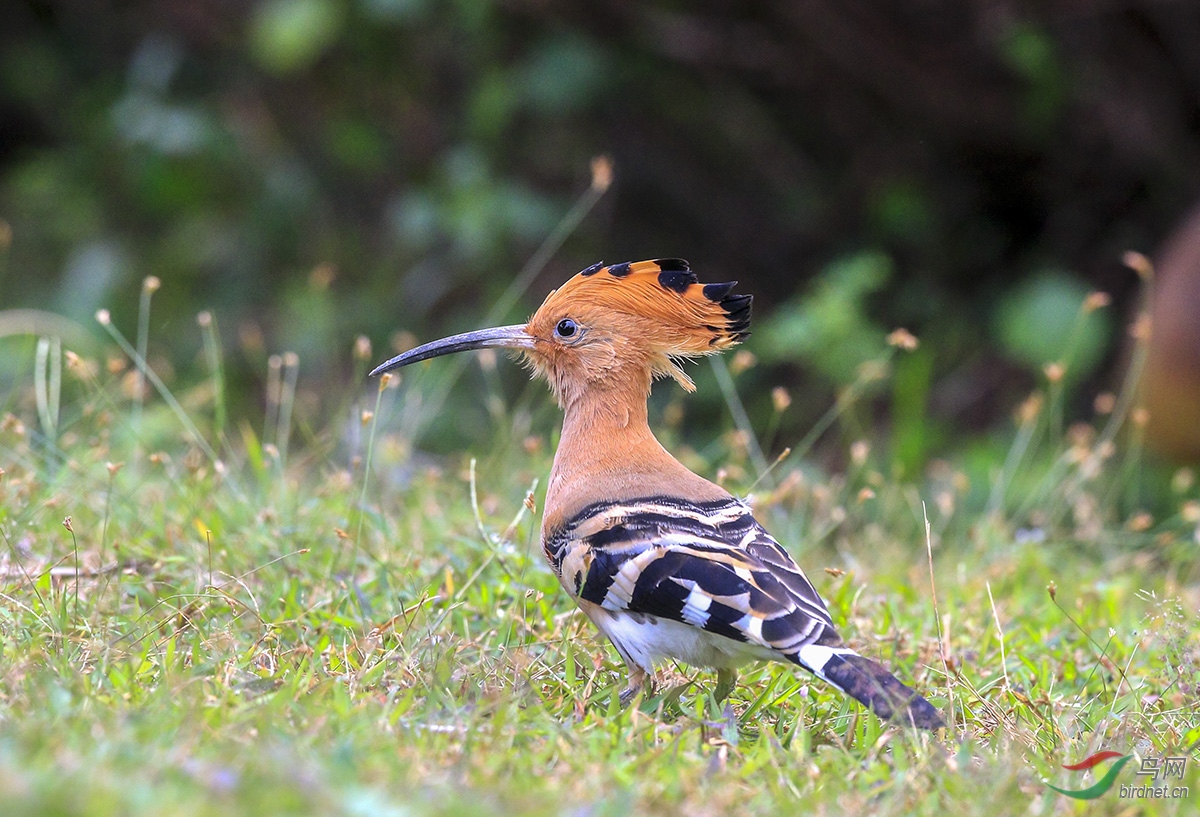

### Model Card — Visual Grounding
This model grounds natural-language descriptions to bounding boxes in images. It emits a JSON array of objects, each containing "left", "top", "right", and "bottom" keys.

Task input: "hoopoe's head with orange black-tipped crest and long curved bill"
[{"left": 371, "top": 258, "right": 751, "bottom": 406}]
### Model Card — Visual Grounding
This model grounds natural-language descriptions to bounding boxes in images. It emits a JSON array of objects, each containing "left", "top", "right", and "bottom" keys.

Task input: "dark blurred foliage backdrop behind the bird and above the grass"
[{"left": 0, "top": 0, "right": 1200, "bottom": 459}]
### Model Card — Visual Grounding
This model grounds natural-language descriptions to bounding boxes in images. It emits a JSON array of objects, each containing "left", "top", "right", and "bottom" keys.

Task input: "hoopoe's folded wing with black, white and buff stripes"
[{"left": 546, "top": 497, "right": 841, "bottom": 661}]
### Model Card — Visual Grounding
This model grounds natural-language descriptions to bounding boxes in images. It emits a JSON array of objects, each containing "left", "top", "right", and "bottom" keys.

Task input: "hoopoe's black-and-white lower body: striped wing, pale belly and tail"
[{"left": 544, "top": 497, "right": 944, "bottom": 729}]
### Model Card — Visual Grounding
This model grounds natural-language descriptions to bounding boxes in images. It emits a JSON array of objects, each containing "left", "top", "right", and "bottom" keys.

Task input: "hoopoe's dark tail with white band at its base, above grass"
[{"left": 794, "top": 644, "right": 946, "bottom": 729}]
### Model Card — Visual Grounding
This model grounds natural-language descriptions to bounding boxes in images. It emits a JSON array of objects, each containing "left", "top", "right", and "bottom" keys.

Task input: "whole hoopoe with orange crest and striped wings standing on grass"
[{"left": 371, "top": 258, "right": 944, "bottom": 729}]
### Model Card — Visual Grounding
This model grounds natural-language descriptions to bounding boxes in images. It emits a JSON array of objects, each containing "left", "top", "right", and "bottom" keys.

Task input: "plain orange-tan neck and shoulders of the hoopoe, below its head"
[{"left": 542, "top": 383, "right": 730, "bottom": 533}]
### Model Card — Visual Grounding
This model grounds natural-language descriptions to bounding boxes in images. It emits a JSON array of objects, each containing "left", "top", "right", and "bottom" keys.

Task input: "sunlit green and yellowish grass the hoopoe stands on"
[{"left": 0, "top": 283, "right": 1200, "bottom": 816}]
